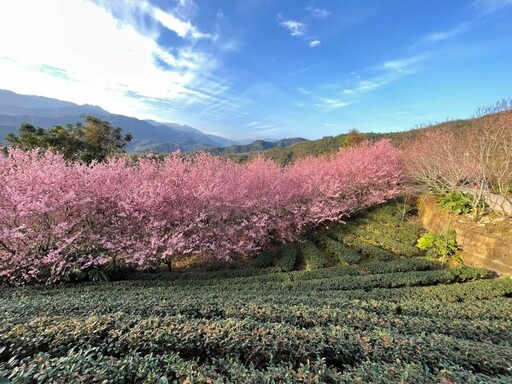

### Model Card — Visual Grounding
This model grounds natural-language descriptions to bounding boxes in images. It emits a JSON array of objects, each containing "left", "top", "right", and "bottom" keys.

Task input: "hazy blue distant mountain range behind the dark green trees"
[{"left": 0, "top": 90, "right": 304, "bottom": 153}]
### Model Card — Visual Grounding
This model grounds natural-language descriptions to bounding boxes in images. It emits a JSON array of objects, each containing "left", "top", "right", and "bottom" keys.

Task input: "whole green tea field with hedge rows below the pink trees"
[{"left": 0, "top": 204, "right": 512, "bottom": 383}]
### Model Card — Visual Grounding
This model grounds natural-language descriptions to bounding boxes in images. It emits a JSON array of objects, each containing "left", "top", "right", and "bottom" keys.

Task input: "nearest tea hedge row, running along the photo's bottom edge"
[{"left": 3, "top": 348, "right": 510, "bottom": 384}]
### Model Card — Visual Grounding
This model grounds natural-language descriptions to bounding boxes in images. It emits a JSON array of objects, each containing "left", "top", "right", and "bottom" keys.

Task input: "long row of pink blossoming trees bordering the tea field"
[{"left": 0, "top": 141, "right": 403, "bottom": 283}]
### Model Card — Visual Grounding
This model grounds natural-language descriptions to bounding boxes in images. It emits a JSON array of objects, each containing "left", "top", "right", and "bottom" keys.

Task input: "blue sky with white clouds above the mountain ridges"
[{"left": 0, "top": 0, "right": 512, "bottom": 139}]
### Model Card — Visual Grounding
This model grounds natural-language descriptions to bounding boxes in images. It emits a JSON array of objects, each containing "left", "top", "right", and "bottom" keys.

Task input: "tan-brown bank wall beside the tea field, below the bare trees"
[{"left": 419, "top": 196, "right": 512, "bottom": 274}]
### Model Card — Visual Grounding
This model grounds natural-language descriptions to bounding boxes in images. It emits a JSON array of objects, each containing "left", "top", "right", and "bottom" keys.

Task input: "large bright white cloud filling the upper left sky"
[{"left": 0, "top": 0, "right": 222, "bottom": 117}]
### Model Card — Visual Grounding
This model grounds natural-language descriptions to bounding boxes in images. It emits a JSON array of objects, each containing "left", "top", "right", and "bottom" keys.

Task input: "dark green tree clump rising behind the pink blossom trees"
[{"left": 5, "top": 116, "right": 132, "bottom": 164}]
